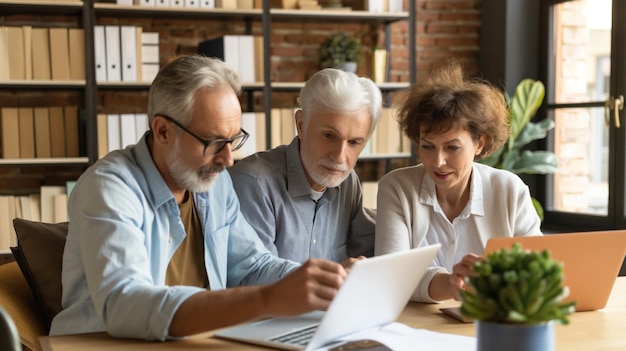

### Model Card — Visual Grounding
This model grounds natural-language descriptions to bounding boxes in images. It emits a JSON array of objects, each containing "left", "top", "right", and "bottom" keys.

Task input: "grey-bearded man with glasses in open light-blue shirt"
[{"left": 50, "top": 56, "right": 346, "bottom": 340}]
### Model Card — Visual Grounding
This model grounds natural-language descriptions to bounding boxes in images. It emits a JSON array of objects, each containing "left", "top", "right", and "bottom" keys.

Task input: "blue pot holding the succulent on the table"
[{"left": 475, "top": 321, "right": 555, "bottom": 351}]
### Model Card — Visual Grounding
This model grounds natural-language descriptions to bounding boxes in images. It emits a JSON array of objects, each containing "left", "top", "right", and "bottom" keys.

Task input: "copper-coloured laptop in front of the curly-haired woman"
[{"left": 484, "top": 230, "right": 626, "bottom": 311}]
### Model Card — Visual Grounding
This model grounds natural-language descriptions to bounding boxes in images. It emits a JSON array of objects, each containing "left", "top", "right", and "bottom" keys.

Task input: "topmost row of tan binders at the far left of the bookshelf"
[{"left": 0, "top": 26, "right": 85, "bottom": 80}]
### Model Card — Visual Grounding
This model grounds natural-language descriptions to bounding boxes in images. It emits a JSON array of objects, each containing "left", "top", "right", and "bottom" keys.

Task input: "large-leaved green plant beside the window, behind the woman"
[{"left": 479, "top": 79, "right": 557, "bottom": 220}]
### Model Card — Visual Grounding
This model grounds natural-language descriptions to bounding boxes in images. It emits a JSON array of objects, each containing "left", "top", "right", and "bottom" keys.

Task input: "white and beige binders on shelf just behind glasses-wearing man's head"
[{"left": 198, "top": 35, "right": 264, "bottom": 83}]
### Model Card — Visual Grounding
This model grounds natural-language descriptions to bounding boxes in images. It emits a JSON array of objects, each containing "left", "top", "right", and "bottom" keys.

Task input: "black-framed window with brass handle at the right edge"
[{"left": 542, "top": 0, "right": 626, "bottom": 230}]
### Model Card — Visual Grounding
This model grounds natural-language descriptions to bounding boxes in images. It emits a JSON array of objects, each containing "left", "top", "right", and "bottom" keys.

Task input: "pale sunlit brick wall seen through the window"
[{"left": 553, "top": 1, "right": 588, "bottom": 212}]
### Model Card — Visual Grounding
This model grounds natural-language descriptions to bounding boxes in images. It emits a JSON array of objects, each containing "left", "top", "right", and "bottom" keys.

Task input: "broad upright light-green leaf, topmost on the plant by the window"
[{"left": 509, "top": 79, "right": 545, "bottom": 149}]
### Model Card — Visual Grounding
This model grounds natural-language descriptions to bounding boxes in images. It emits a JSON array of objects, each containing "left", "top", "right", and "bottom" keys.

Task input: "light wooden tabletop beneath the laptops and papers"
[{"left": 40, "top": 277, "right": 626, "bottom": 351}]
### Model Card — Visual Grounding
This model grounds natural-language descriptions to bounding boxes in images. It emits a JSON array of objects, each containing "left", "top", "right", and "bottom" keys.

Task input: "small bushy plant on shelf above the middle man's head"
[{"left": 319, "top": 33, "right": 361, "bottom": 72}]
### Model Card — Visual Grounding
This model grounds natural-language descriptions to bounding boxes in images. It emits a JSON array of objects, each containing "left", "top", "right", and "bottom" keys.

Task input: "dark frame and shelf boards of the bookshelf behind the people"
[{"left": 0, "top": 0, "right": 415, "bottom": 165}]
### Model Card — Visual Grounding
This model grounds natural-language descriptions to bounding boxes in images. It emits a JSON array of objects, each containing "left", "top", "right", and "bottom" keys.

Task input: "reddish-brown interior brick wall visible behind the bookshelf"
[{"left": 0, "top": 0, "right": 480, "bottom": 194}]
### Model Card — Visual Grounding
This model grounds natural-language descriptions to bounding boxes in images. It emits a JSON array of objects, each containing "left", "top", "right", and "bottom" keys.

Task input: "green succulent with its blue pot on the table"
[{"left": 461, "top": 244, "right": 575, "bottom": 351}]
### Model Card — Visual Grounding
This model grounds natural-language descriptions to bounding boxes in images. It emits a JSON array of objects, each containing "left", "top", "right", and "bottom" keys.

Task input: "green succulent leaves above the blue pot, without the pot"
[{"left": 461, "top": 244, "right": 575, "bottom": 325}]
